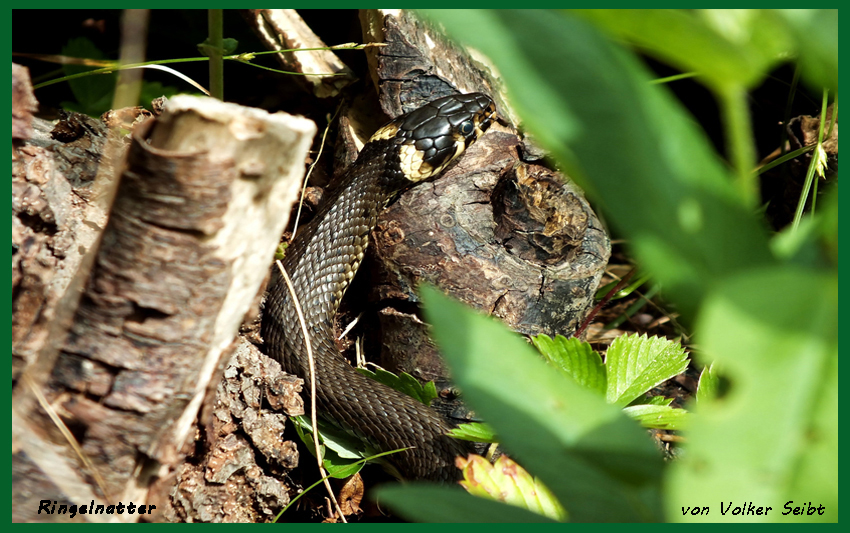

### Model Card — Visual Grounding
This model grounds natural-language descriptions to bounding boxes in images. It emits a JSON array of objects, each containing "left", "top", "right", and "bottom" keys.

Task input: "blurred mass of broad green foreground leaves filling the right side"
[{"left": 382, "top": 10, "right": 838, "bottom": 521}]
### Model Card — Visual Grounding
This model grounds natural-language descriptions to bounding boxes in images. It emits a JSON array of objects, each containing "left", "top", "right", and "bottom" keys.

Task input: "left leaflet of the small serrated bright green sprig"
[{"left": 531, "top": 335, "right": 607, "bottom": 396}]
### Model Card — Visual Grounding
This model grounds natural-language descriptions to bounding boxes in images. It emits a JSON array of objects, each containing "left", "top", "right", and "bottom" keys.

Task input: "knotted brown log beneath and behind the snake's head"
[{"left": 350, "top": 10, "right": 610, "bottom": 421}]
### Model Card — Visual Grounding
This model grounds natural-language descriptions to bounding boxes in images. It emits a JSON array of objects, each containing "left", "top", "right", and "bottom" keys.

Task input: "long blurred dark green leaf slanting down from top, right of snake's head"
[{"left": 427, "top": 10, "right": 774, "bottom": 316}]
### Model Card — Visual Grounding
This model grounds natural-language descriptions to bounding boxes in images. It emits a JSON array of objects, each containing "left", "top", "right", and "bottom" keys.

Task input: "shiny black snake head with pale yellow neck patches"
[{"left": 369, "top": 93, "right": 497, "bottom": 182}]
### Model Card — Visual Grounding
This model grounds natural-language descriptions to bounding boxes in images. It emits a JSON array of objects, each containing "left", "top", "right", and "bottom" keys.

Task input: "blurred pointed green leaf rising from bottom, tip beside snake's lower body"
[{"left": 421, "top": 286, "right": 662, "bottom": 521}]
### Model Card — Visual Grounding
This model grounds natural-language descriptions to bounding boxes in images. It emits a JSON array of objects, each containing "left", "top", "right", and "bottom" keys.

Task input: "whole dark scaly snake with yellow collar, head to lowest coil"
[{"left": 261, "top": 93, "right": 496, "bottom": 482}]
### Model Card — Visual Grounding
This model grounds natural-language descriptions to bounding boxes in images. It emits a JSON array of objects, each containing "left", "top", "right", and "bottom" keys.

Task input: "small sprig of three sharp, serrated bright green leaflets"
[{"left": 531, "top": 335, "right": 688, "bottom": 429}]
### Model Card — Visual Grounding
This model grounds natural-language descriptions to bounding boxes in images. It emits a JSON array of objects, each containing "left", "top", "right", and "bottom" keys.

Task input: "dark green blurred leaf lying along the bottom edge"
[{"left": 375, "top": 483, "right": 552, "bottom": 524}]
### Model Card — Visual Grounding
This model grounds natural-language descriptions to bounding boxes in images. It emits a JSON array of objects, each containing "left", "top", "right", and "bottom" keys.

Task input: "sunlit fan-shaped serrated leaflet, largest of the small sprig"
[{"left": 605, "top": 334, "right": 688, "bottom": 407}]
